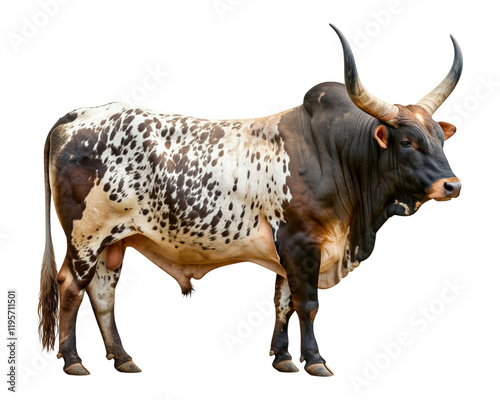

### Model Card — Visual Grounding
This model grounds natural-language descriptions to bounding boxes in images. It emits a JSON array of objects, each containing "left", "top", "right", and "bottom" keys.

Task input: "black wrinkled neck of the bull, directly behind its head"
[{"left": 330, "top": 113, "right": 396, "bottom": 262}]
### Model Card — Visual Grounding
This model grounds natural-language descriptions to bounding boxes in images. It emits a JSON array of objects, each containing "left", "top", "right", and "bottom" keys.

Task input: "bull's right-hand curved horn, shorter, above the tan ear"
[{"left": 417, "top": 35, "right": 463, "bottom": 115}]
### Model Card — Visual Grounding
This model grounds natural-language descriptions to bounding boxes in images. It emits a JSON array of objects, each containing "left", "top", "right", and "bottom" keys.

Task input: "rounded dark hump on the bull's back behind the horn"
[{"left": 304, "top": 82, "right": 354, "bottom": 115}]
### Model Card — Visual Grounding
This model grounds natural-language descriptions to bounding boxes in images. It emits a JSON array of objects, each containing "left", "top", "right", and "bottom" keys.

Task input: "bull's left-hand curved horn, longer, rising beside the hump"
[{"left": 330, "top": 24, "right": 399, "bottom": 125}]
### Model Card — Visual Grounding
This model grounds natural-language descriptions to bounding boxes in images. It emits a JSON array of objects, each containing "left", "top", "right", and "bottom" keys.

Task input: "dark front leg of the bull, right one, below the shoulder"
[{"left": 280, "top": 239, "right": 333, "bottom": 376}]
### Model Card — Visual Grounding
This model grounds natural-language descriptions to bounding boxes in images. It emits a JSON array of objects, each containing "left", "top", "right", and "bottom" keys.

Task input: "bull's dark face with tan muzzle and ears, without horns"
[{"left": 373, "top": 105, "right": 461, "bottom": 215}]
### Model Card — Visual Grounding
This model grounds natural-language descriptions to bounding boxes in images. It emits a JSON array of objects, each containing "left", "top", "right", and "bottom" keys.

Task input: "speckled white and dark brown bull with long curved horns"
[{"left": 39, "top": 26, "right": 462, "bottom": 376}]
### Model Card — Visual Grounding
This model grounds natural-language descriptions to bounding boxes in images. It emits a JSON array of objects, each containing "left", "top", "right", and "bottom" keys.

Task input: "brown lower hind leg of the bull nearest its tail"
[{"left": 57, "top": 253, "right": 95, "bottom": 375}]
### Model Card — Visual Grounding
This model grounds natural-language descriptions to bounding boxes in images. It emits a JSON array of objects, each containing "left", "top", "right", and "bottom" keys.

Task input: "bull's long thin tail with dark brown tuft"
[{"left": 38, "top": 130, "right": 59, "bottom": 351}]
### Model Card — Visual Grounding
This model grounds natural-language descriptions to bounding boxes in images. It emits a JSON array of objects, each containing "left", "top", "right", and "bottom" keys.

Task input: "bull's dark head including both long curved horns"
[{"left": 331, "top": 25, "right": 463, "bottom": 215}]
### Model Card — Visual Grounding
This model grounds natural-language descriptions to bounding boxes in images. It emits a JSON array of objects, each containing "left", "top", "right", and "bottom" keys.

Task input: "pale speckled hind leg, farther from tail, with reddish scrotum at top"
[{"left": 87, "top": 243, "right": 141, "bottom": 372}]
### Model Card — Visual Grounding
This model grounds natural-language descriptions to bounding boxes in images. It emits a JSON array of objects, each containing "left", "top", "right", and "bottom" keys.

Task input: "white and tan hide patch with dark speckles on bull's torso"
[{"left": 58, "top": 103, "right": 291, "bottom": 278}]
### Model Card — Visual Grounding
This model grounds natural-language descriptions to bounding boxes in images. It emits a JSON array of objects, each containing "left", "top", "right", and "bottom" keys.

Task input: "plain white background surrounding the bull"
[{"left": 0, "top": 0, "right": 500, "bottom": 400}]
